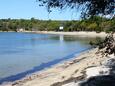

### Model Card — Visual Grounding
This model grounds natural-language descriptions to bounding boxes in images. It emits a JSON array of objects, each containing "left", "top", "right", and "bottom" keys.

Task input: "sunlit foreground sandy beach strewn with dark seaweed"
[{"left": 2, "top": 48, "right": 111, "bottom": 86}]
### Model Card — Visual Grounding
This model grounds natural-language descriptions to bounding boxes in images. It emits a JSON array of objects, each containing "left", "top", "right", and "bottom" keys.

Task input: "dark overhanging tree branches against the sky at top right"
[{"left": 37, "top": 0, "right": 115, "bottom": 18}]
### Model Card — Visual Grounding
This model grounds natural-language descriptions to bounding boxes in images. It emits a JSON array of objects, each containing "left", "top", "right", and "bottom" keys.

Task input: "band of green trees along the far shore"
[{"left": 0, "top": 16, "right": 115, "bottom": 32}]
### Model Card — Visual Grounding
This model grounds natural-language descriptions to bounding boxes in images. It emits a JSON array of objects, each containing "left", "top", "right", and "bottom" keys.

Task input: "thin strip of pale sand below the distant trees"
[{"left": 0, "top": 31, "right": 115, "bottom": 38}]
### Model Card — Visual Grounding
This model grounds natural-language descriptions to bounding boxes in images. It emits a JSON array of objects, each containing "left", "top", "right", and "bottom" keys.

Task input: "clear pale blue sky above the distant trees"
[{"left": 0, "top": 0, "right": 80, "bottom": 20}]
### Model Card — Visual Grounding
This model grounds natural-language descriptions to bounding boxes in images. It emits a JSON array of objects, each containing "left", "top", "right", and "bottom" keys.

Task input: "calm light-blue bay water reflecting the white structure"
[{"left": 0, "top": 32, "right": 92, "bottom": 82}]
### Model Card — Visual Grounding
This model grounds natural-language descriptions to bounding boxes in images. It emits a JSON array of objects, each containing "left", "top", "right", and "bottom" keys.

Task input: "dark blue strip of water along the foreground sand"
[{"left": 0, "top": 47, "right": 92, "bottom": 84}]
